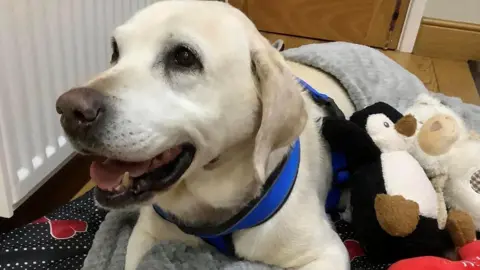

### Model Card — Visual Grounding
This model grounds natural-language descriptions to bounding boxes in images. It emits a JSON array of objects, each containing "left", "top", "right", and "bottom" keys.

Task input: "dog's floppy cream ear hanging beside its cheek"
[{"left": 251, "top": 38, "right": 307, "bottom": 181}]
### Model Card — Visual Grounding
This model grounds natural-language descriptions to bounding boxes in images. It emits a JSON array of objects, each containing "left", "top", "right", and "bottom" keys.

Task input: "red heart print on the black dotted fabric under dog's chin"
[{"left": 32, "top": 217, "right": 88, "bottom": 240}]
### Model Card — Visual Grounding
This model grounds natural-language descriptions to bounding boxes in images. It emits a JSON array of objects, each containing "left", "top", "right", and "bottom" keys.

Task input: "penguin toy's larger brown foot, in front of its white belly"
[{"left": 375, "top": 194, "right": 420, "bottom": 237}]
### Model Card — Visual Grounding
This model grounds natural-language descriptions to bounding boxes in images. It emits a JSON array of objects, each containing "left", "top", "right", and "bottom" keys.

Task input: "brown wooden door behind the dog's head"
[{"left": 229, "top": 0, "right": 410, "bottom": 48}]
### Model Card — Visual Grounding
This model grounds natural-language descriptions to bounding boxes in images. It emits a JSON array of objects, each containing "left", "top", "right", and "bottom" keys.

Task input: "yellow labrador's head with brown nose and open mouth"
[{"left": 57, "top": 1, "right": 306, "bottom": 208}]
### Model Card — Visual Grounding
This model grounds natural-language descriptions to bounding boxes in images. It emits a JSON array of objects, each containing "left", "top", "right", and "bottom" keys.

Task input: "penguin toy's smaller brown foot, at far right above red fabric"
[{"left": 446, "top": 210, "right": 476, "bottom": 247}]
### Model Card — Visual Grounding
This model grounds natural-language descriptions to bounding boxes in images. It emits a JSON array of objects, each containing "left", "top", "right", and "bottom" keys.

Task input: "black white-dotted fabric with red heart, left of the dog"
[{"left": 0, "top": 191, "right": 106, "bottom": 270}]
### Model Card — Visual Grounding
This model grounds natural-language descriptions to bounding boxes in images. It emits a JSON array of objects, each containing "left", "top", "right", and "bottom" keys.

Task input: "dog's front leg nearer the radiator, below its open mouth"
[{"left": 125, "top": 206, "right": 201, "bottom": 270}]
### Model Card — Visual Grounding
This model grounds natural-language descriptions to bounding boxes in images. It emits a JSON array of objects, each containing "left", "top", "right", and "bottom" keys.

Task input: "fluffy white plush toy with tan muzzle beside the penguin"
[{"left": 405, "top": 94, "right": 480, "bottom": 231}]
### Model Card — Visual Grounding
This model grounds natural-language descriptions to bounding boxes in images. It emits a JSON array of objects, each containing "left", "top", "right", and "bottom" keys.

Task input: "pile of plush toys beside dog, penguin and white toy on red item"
[{"left": 323, "top": 95, "right": 480, "bottom": 270}]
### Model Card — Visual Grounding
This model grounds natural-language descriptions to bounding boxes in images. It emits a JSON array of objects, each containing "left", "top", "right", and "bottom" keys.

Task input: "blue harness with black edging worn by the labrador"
[{"left": 153, "top": 79, "right": 348, "bottom": 256}]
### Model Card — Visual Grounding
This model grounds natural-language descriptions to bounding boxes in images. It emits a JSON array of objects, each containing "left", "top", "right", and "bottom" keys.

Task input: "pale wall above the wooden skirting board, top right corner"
[{"left": 424, "top": 0, "right": 480, "bottom": 24}]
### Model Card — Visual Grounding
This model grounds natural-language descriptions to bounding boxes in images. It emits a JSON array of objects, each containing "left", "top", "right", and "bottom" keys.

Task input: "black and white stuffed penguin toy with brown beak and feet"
[{"left": 322, "top": 103, "right": 453, "bottom": 263}]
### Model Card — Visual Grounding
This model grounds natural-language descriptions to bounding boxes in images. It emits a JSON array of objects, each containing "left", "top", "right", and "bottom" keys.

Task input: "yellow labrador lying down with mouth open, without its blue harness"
[{"left": 57, "top": 1, "right": 353, "bottom": 270}]
